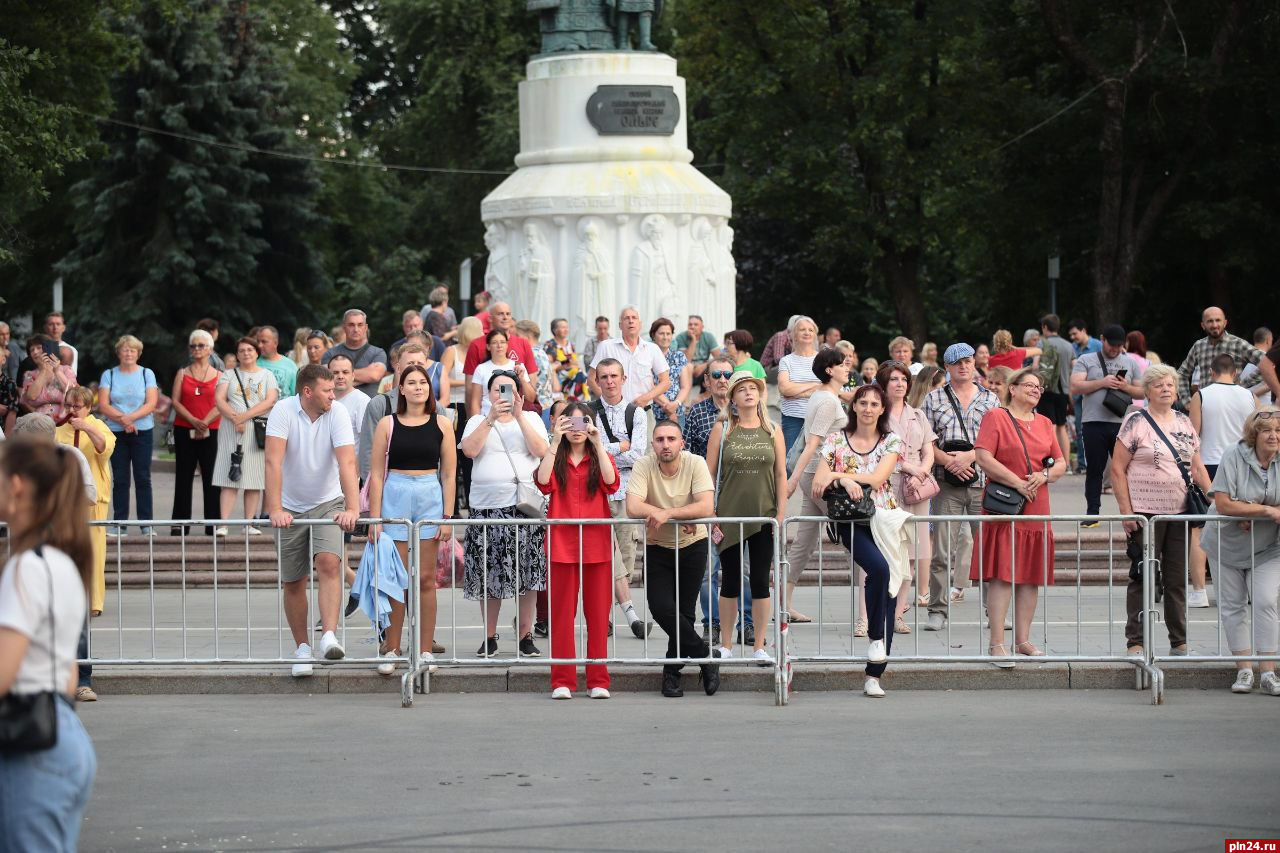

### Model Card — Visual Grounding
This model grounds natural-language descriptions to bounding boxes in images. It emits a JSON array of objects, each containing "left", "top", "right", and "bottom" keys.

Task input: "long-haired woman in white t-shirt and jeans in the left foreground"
[{"left": 0, "top": 435, "right": 97, "bottom": 850}]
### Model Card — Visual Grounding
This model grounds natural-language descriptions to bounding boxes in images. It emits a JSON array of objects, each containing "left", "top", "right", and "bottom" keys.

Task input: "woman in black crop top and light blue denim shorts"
[{"left": 369, "top": 365, "right": 457, "bottom": 675}]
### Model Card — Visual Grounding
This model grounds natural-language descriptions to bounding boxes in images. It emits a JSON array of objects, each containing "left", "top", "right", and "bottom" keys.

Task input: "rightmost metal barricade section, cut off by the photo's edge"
[{"left": 1144, "top": 515, "right": 1280, "bottom": 697}]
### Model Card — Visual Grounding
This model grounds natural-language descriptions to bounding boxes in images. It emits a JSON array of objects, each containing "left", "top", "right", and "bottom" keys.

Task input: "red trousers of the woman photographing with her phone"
[{"left": 548, "top": 561, "right": 613, "bottom": 690}]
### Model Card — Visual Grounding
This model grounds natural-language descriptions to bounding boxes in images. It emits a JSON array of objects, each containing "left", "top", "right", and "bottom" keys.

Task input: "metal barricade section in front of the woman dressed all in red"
[{"left": 402, "top": 517, "right": 786, "bottom": 707}]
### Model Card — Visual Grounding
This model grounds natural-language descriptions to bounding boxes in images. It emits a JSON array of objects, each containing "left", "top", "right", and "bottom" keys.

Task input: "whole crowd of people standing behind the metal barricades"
[{"left": 0, "top": 295, "right": 1280, "bottom": 712}]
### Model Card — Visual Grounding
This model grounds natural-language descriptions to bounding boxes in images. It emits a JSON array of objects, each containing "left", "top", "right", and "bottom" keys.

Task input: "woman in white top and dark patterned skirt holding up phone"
[{"left": 462, "top": 371, "right": 550, "bottom": 657}]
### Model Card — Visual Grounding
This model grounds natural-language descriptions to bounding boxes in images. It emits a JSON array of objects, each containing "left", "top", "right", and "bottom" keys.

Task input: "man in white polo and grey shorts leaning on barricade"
[{"left": 266, "top": 365, "right": 360, "bottom": 676}]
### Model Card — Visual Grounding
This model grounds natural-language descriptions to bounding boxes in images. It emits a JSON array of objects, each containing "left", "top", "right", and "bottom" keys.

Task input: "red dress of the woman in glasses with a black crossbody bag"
[{"left": 969, "top": 409, "right": 1060, "bottom": 585}]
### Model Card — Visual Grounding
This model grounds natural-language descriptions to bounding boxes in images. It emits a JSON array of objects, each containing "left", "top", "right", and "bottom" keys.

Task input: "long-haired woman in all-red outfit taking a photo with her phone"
[{"left": 535, "top": 402, "right": 622, "bottom": 699}]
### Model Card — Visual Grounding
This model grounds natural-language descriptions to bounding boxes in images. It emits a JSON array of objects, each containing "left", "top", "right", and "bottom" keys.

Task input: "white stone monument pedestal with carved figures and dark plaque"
[{"left": 480, "top": 51, "right": 737, "bottom": 345}]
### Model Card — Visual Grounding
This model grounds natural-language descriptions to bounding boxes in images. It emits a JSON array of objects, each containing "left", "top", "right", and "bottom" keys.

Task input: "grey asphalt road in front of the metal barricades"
[{"left": 81, "top": 688, "right": 1280, "bottom": 853}]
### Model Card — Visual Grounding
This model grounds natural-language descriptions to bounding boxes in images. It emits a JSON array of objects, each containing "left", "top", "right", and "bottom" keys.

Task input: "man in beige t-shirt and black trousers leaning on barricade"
[{"left": 627, "top": 420, "right": 719, "bottom": 697}]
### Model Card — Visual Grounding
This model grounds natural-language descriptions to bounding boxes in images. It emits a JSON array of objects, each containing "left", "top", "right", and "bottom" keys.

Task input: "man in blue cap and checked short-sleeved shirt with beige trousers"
[{"left": 924, "top": 343, "right": 1000, "bottom": 631}]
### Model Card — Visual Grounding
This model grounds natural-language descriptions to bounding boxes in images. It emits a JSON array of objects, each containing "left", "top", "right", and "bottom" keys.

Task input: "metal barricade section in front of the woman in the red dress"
[{"left": 780, "top": 515, "right": 1160, "bottom": 701}]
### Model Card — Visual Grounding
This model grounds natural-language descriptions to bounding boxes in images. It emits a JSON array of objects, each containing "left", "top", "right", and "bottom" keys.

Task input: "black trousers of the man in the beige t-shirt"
[{"left": 644, "top": 539, "right": 710, "bottom": 674}]
